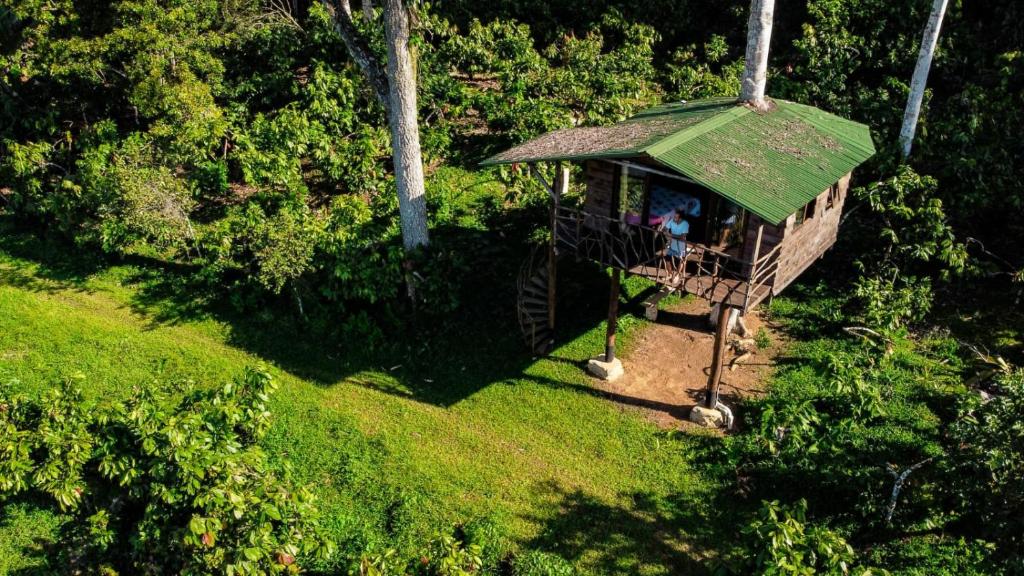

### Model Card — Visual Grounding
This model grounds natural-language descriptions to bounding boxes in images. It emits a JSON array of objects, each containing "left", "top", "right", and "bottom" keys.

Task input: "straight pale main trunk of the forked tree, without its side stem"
[{"left": 383, "top": 0, "right": 430, "bottom": 250}]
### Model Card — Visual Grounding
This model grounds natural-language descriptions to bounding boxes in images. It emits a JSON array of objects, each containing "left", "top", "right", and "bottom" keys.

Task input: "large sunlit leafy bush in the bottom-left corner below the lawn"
[{"left": 0, "top": 370, "right": 331, "bottom": 574}]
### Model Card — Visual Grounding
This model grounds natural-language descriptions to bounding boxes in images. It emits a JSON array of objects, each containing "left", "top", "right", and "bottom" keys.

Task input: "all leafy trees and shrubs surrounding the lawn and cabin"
[{"left": 0, "top": 0, "right": 1024, "bottom": 575}]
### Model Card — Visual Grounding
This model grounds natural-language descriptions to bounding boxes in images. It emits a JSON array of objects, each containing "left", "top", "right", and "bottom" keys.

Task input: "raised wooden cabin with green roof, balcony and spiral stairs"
[{"left": 484, "top": 98, "right": 874, "bottom": 360}]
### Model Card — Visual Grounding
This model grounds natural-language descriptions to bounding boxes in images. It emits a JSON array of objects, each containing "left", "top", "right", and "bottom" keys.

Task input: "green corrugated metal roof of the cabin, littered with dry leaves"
[{"left": 483, "top": 98, "right": 874, "bottom": 223}]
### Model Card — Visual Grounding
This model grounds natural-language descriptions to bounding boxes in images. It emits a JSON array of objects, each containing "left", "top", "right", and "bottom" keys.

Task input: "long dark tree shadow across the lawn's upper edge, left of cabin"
[{"left": 0, "top": 211, "right": 608, "bottom": 406}]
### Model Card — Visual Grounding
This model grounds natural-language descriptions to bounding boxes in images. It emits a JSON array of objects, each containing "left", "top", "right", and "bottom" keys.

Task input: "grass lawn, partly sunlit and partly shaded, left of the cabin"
[{"left": 0, "top": 212, "right": 717, "bottom": 574}]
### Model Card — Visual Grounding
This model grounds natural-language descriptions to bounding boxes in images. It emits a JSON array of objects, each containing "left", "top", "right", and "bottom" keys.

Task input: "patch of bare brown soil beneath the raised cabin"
[{"left": 598, "top": 298, "right": 782, "bottom": 429}]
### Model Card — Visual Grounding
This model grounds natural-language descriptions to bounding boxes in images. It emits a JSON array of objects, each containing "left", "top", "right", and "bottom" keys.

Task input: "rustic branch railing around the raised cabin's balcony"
[{"left": 554, "top": 207, "right": 779, "bottom": 310}]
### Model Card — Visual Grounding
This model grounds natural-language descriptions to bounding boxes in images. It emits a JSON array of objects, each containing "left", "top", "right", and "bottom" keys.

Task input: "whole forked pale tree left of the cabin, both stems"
[{"left": 321, "top": 0, "right": 430, "bottom": 250}]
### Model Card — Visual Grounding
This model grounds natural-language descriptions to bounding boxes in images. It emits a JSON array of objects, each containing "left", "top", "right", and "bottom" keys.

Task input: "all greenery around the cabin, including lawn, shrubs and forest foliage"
[{"left": 0, "top": 0, "right": 1024, "bottom": 576}]
